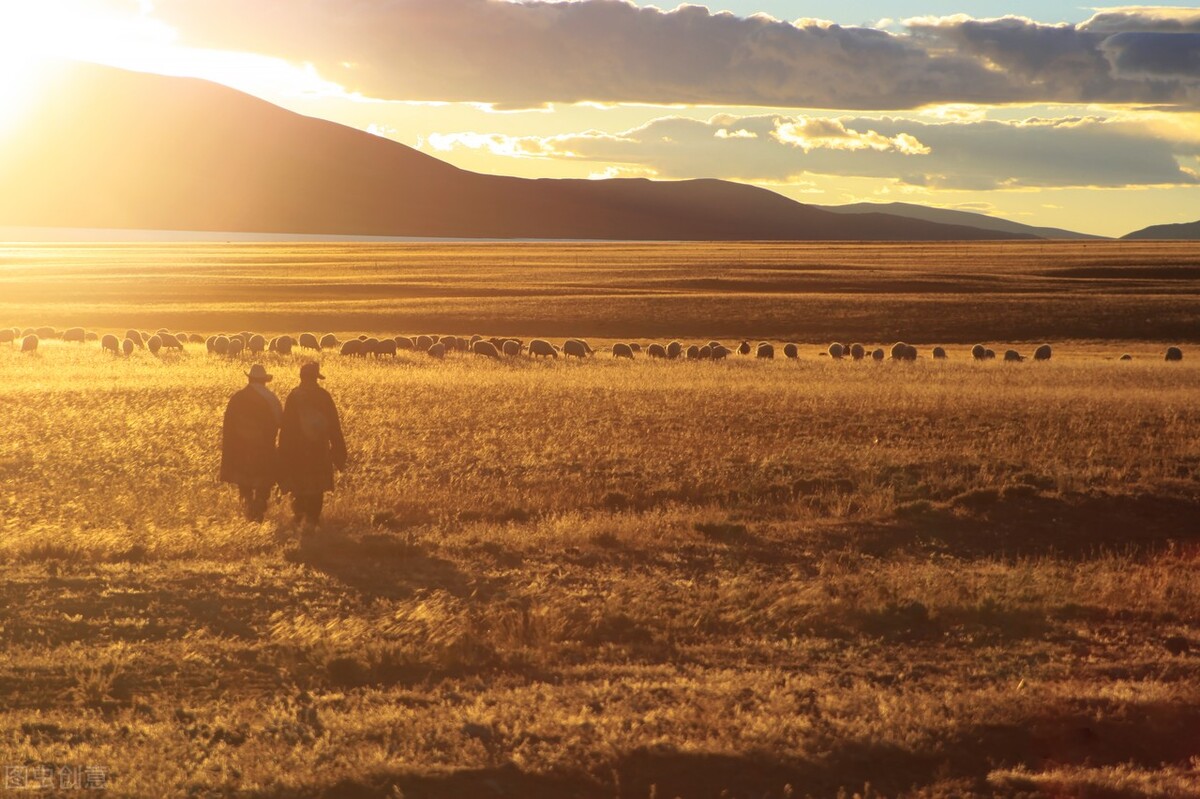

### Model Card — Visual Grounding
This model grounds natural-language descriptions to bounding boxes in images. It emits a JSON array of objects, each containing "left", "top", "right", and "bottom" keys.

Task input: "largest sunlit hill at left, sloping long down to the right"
[{"left": 0, "top": 64, "right": 1026, "bottom": 241}]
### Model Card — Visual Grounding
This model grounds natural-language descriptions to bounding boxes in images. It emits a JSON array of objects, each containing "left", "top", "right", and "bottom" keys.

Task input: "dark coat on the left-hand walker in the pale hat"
[{"left": 221, "top": 385, "right": 280, "bottom": 486}]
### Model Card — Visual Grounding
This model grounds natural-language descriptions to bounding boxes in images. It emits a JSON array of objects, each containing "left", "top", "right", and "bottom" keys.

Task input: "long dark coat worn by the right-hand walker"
[{"left": 280, "top": 383, "right": 346, "bottom": 494}]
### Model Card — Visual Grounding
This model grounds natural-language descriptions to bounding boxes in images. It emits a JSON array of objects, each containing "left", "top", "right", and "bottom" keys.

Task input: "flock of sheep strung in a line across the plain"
[{"left": 0, "top": 328, "right": 1183, "bottom": 362}]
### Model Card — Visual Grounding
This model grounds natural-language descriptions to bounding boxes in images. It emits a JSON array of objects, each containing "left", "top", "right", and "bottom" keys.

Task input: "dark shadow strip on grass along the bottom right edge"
[{"left": 251, "top": 701, "right": 1200, "bottom": 799}]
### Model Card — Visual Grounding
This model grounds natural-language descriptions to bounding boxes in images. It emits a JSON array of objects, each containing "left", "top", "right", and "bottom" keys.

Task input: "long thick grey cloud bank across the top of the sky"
[{"left": 154, "top": 0, "right": 1200, "bottom": 110}]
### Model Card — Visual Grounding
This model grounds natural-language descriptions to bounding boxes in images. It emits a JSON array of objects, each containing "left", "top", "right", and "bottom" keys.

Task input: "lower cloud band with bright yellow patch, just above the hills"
[{"left": 430, "top": 115, "right": 1200, "bottom": 191}]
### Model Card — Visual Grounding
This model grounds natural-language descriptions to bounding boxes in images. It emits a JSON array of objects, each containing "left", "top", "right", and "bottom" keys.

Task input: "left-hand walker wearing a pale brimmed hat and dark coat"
[{"left": 221, "top": 364, "right": 283, "bottom": 522}]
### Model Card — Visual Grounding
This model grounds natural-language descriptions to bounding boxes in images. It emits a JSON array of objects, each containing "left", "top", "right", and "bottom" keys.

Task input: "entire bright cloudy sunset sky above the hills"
[{"left": 0, "top": 0, "right": 1200, "bottom": 235}]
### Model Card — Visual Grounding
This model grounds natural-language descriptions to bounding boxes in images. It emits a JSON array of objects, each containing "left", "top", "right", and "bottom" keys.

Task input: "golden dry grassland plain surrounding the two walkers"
[{"left": 0, "top": 239, "right": 1200, "bottom": 799}]
